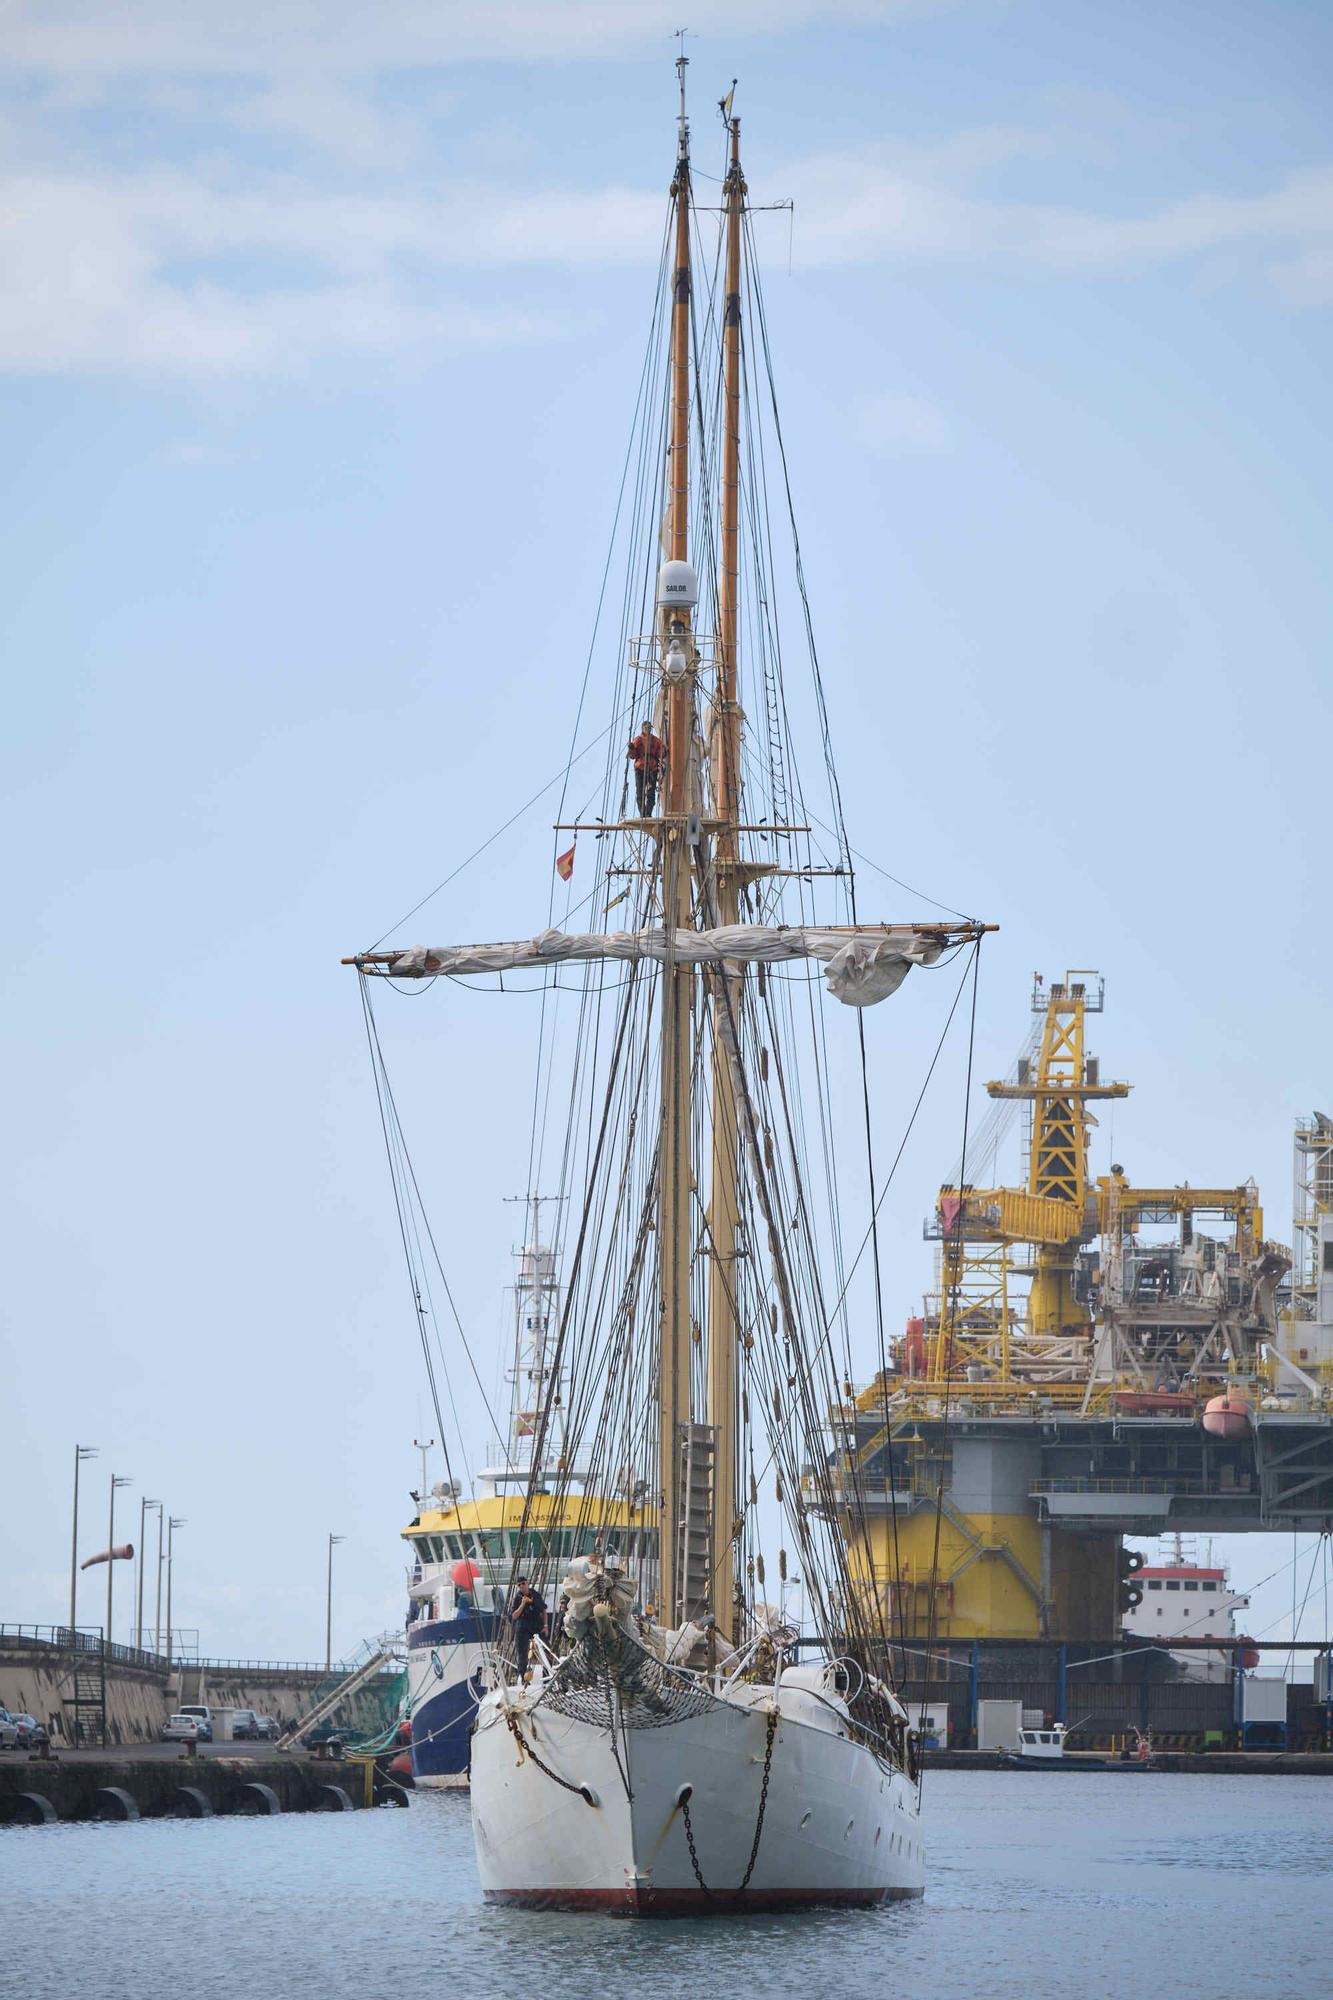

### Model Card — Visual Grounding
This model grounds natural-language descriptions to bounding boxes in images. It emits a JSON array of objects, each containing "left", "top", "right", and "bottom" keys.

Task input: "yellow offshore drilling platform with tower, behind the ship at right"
[{"left": 831, "top": 972, "right": 1333, "bottom": 1644}]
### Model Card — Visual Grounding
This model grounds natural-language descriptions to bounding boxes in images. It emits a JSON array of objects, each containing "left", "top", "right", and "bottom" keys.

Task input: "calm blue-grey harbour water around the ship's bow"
[{"left": 0, "top": 1772, "right": 1333, "bottom": 2000}]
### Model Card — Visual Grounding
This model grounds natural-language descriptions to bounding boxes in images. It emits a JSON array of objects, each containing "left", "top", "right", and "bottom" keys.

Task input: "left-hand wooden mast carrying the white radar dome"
[{"left": 656, "top": 54, "right": 695, "bottom": 1624}]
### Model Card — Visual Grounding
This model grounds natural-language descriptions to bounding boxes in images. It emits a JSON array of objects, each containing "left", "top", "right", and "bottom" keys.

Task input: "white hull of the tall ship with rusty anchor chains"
[{"left": 472, "top": 1686, "right": 925, "bottom": 1916}]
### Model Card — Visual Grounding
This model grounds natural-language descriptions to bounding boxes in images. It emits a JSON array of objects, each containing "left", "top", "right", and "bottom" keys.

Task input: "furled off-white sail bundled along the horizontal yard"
[{"left": 364, "top": 924, "right": 955, "bottom": 1006}]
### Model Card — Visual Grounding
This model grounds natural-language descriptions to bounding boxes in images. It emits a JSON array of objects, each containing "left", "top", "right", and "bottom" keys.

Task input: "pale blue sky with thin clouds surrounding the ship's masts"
[{"left": 0, "top": 0, "right": 1333, "bottom": 1660}]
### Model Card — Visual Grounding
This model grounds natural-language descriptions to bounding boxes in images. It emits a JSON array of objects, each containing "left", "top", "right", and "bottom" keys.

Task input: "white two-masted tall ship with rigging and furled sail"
[{"left": 350, "top": 60, "right": 985, "bottom": 1916}]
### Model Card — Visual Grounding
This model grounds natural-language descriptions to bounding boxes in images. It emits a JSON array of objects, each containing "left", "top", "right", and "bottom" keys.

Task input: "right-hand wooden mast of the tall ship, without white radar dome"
[{"left": 709, "top": 118, "right": 745, "bottom": 1640}]
